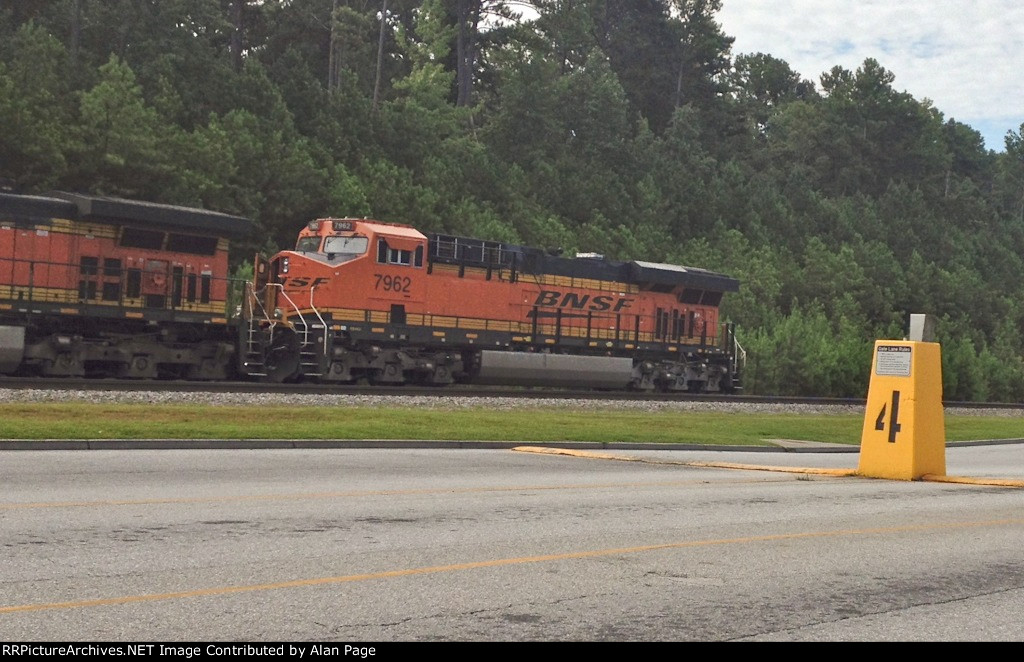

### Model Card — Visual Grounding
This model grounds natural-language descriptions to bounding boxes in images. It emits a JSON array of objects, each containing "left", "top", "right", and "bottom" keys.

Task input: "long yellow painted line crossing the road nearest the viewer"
[{"left": 0, "top": 520, "right": 1024, "bottom": 614}]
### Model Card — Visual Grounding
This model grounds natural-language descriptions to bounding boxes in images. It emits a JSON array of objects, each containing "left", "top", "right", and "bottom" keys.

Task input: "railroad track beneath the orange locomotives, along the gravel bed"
[{"left": 0, "top": 377, "right": 1024, "bottom": 410}]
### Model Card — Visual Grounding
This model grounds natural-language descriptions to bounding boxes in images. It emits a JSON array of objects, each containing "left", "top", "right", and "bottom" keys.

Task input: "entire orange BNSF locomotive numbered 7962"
[{"left": 239, "top": 218, "right": 742, "bottom": 392}]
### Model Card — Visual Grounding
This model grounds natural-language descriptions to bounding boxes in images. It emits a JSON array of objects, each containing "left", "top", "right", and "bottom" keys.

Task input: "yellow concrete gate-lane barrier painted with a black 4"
[{"left": 857, "top": 340, "right": 946, "bottom": 481}]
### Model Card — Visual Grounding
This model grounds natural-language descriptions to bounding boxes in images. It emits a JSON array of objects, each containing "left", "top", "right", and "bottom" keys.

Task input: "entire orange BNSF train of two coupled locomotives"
[{"left": 0, "top": 189, "right": 743, "bottom": 392}]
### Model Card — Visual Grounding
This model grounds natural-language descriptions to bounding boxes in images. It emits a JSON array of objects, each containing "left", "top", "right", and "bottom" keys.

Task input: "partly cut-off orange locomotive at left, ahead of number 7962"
[{"left": 0, "top": 193, "right": 253, "bottom": 380}]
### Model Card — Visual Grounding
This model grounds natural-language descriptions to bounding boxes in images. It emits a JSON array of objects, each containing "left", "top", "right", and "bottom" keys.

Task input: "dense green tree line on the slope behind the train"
[{"left": 0, "top": 0, "right": 1024, "bottom": 402}]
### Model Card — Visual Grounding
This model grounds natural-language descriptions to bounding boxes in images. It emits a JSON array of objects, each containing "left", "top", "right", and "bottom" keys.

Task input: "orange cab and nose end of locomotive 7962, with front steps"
[{"left": 243, "top": 218, "right": 427, "bottom": 381}]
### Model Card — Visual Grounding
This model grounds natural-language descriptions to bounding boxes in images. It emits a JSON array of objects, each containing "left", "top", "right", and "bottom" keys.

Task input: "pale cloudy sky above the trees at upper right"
[{"left": 716, "top": 0, "right": 1024, "bottom": 152}]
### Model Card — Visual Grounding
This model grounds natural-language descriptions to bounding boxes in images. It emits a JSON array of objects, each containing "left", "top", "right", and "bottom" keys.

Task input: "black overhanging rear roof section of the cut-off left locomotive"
[{"left": 48, "top": 192, "right": 253, "bottom": 237}]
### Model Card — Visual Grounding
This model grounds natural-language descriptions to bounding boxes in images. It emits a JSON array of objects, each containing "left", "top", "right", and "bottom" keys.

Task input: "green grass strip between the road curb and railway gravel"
[{"left": 0, "top": 404, "right": 1024, "bottom": 446}]
